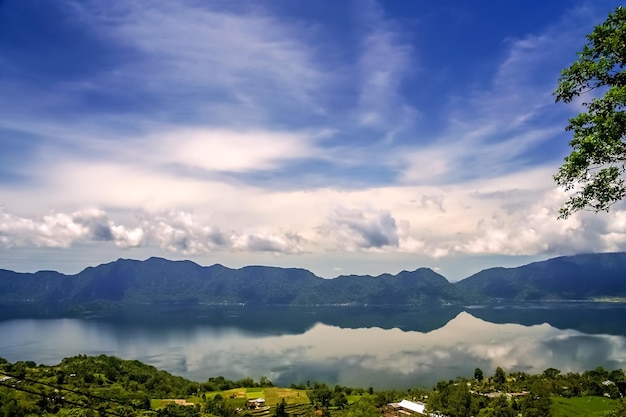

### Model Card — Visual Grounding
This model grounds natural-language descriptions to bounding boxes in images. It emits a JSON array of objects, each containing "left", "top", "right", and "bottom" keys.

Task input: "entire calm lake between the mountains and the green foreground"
[{"left": 0, "top": 304, "right": 626, "bottom": 388}]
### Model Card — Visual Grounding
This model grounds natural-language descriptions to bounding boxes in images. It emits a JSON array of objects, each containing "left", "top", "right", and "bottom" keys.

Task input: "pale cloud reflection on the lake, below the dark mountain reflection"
[{"left": 0, "top": 312, "right": 626, "bottom": 388}]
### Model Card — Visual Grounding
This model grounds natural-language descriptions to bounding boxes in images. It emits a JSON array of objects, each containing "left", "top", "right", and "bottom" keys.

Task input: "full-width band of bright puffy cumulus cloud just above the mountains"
[{"left": 0, "top": 174, "right": 626, "bottom": 270}]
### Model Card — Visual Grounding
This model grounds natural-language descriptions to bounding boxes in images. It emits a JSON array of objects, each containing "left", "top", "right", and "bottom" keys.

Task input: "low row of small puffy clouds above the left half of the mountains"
[{"left": 0, "top": 210, "right": 304, "bottom": 255}]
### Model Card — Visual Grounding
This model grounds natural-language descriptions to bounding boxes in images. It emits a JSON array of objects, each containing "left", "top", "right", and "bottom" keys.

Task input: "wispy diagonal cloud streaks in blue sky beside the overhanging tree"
[{"left": 398, "top": 4, "right": 597, "bottom": 184}]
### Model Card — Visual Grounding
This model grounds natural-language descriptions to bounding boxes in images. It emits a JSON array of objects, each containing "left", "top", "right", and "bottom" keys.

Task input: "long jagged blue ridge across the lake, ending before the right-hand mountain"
[{"left": 0, "top": 258, "right": 461, "bottom": 305}]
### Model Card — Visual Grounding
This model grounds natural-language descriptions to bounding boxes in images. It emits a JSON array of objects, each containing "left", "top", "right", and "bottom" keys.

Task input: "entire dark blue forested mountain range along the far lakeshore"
[{"left": 0, "top": 253, "right": 626, "bottom": 305}]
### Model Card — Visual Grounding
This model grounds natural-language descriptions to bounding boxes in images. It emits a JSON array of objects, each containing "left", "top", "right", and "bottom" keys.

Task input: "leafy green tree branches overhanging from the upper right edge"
[{"left": 554, "top": 7, "right": 626, "bottom": 218}]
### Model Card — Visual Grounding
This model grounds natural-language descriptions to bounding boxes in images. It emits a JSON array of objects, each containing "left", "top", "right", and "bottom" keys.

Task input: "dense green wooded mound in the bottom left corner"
[{"left": 0, "top": 355, "right": 193, "bottom": 417}]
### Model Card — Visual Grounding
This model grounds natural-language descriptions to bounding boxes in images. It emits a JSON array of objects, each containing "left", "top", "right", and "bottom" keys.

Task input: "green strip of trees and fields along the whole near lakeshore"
[{"left": 0, "top": 355, "right": 626, "bottom": 417}]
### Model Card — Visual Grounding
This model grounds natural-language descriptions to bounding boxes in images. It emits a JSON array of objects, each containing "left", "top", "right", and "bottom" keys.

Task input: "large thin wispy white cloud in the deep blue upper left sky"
[{"left": 68, "top": 0, "right": 327, "bottom": 120}]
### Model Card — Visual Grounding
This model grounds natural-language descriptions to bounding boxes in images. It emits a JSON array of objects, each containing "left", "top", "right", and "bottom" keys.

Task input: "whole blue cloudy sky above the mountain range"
[{"left": 0, "top": 0, "right": 626, "bottom": 281}]
